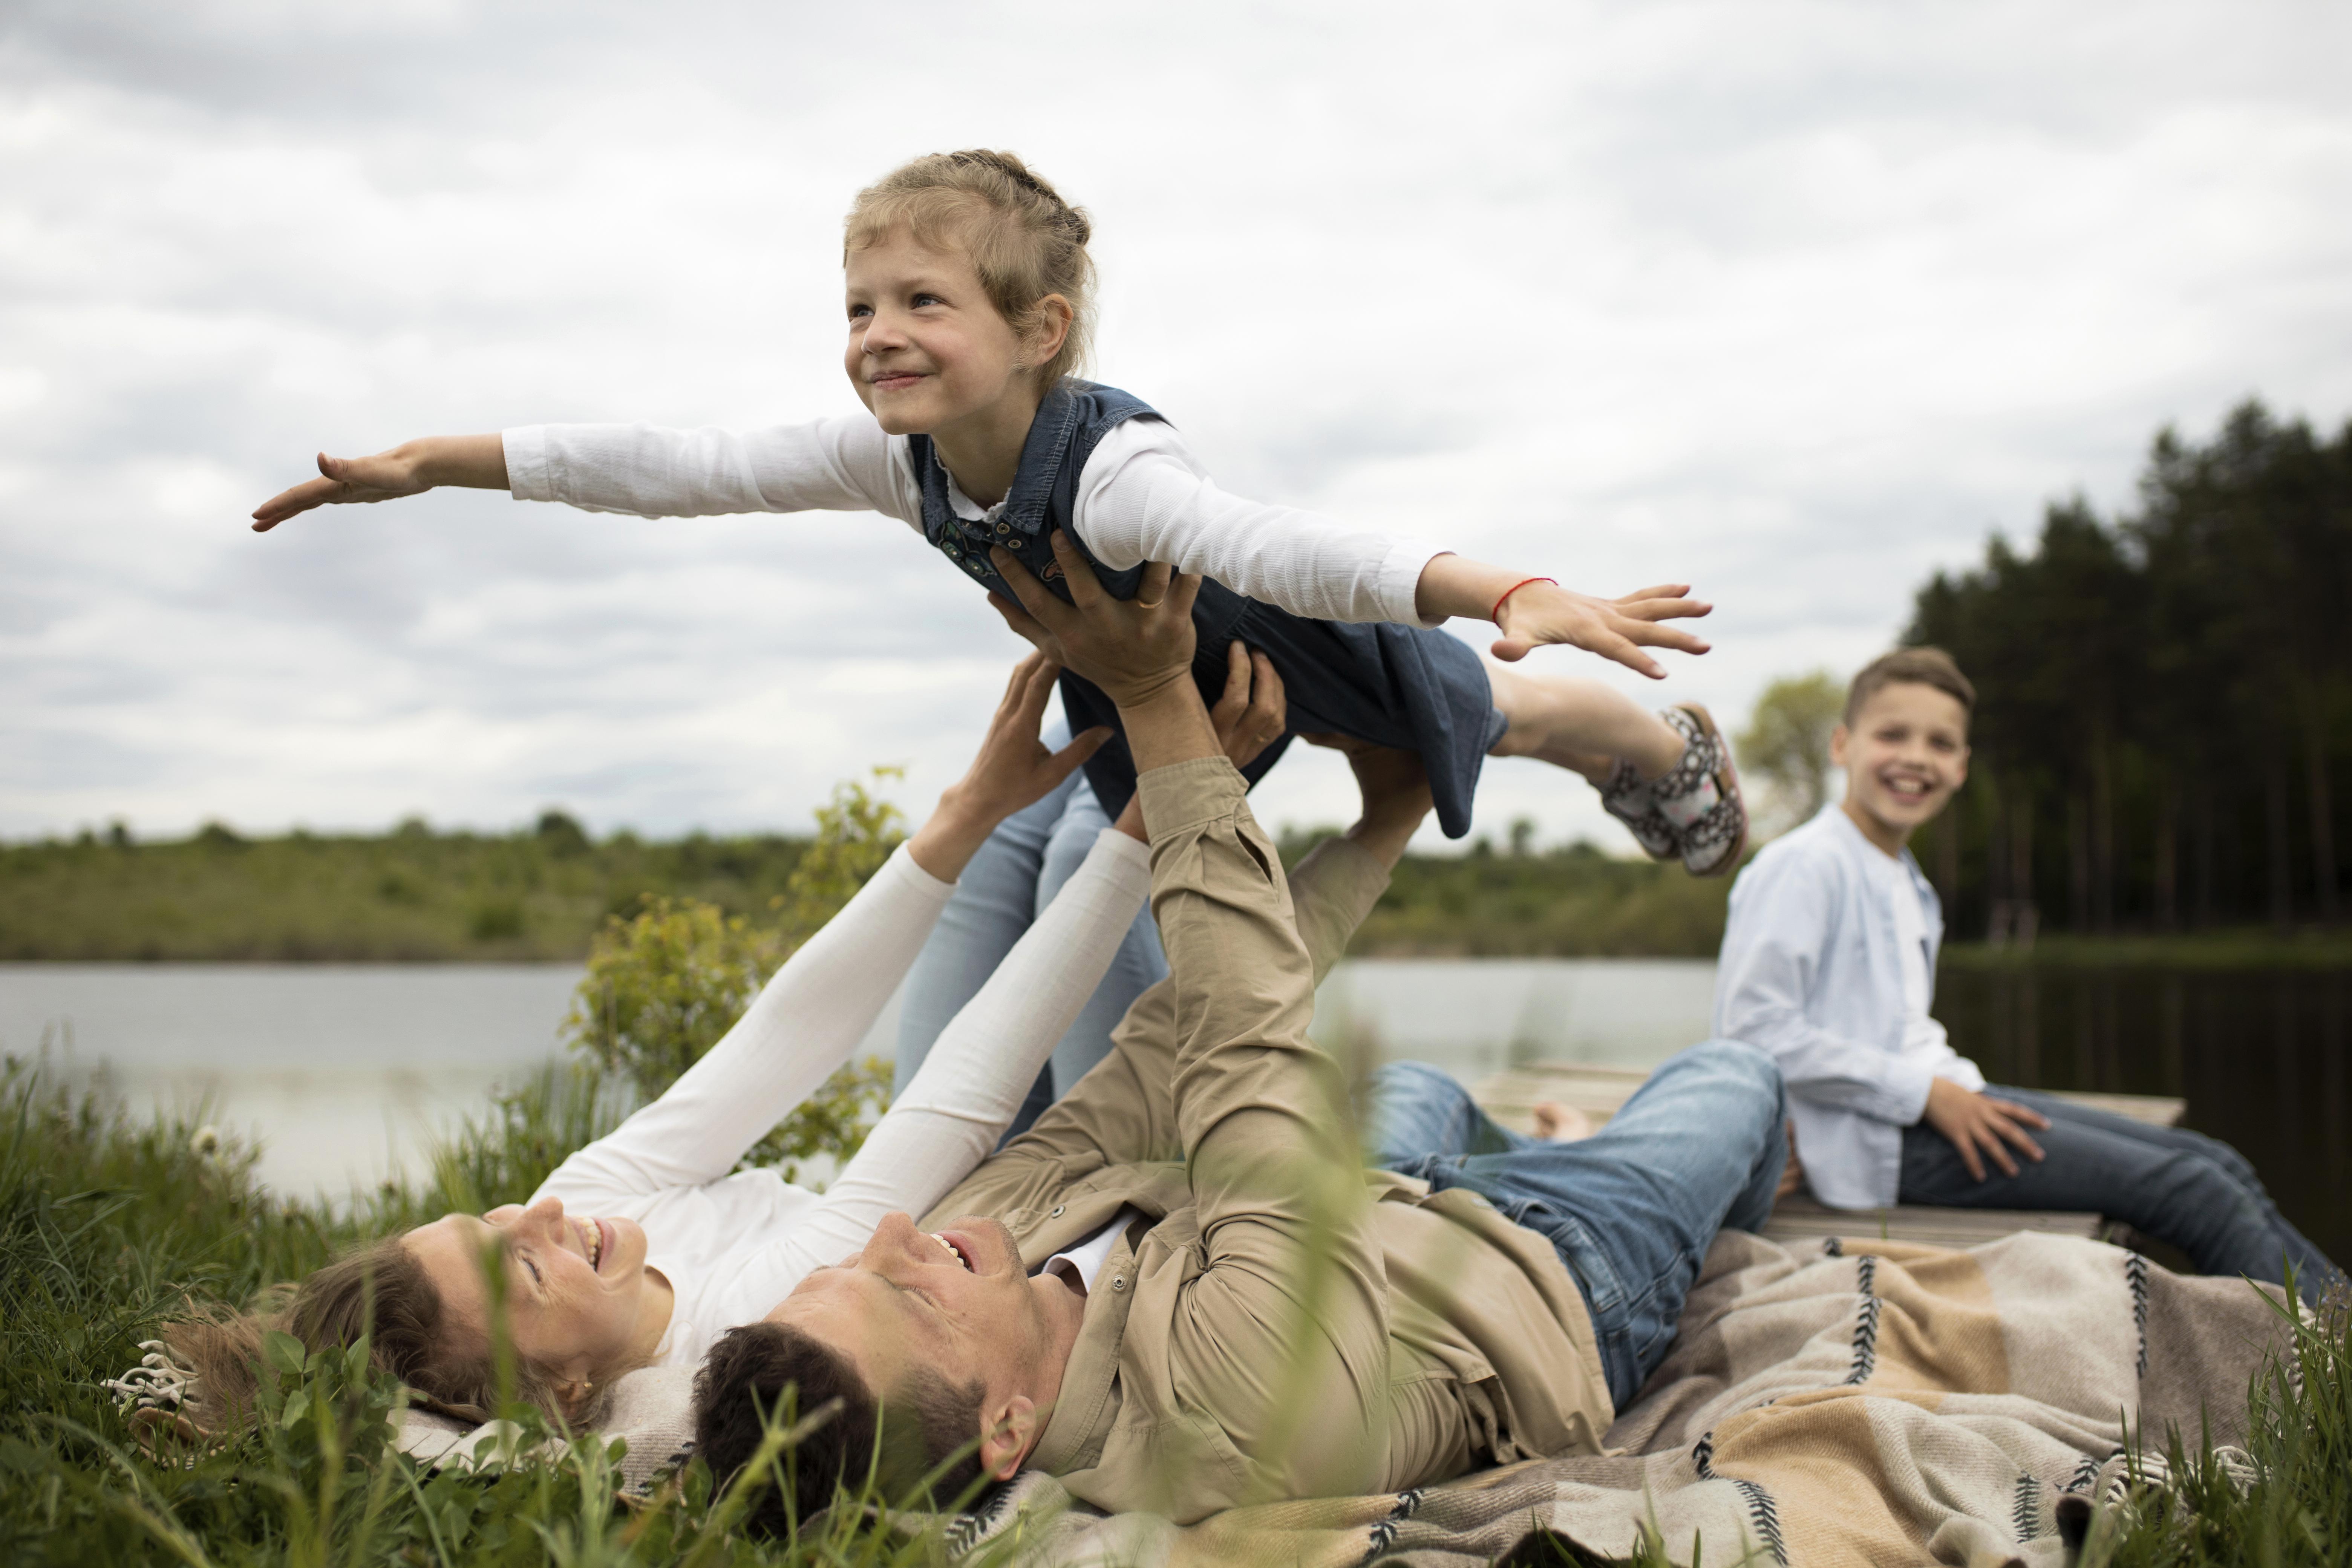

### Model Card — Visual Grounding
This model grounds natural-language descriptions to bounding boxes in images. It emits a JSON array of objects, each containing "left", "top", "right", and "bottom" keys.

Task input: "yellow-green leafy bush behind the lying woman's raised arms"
[{"left": 562, "top": 769, "right": 905, "bottom": 1180}]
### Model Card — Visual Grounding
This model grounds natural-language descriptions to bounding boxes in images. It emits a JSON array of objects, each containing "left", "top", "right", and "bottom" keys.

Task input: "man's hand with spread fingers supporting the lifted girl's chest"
[{"left": 988, "top": 541, "right": 1199, "bottom": 707}]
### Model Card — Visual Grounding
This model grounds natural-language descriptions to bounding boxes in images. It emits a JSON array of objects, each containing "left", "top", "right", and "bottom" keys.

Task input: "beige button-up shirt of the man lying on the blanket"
[{"left": 924, "top": 757, "right": 1614, "bottom": 1521}]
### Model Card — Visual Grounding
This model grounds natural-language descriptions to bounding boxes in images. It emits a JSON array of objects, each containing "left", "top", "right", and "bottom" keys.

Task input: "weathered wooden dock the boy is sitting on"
[{"left": 1472, "top": 1063, "right": 2187, "bottom": 1246}]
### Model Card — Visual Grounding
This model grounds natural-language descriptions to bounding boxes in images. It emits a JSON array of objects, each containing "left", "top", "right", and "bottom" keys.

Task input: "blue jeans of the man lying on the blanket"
[{"left": 1364, "top": 1039, "right": 1787, "bottom": 1410}]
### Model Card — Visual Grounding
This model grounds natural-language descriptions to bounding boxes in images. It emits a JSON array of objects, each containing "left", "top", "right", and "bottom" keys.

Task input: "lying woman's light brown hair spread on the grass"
[{"left": 162, "top": 1237, "right": 564, "bottom": 1434}]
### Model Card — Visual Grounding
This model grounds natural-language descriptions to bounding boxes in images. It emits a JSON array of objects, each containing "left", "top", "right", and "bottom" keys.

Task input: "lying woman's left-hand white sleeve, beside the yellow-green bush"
[{"left": 541, "top": 844, "right": 955, "bottom": 1213}]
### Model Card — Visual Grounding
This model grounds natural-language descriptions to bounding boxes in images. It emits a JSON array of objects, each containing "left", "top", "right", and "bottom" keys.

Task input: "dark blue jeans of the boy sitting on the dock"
[{"left": 1900, "top": 1089, "right": 2343, "bottom": 1302}]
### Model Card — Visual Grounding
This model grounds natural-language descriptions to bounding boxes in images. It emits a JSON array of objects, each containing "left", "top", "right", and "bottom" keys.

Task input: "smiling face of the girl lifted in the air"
[{"left": 842, "top": 228, "right": 1040, "bottom": 437}]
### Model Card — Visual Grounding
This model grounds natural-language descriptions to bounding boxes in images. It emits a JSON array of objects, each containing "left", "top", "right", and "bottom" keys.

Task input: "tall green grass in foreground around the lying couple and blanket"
[{"left": 0, "top": 1060, "right": 2352, "bottom": 1568}]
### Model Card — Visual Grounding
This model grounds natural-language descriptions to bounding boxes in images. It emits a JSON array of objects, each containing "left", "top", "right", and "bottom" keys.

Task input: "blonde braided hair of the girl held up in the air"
[{"left": 842, "top": 150, "right": 1094, "bottom": 390}]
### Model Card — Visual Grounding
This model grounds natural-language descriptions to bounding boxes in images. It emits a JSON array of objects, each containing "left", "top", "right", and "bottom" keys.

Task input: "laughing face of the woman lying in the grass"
[{"left": 404, "top": 1197, "right": 647, "bottom": 1382}]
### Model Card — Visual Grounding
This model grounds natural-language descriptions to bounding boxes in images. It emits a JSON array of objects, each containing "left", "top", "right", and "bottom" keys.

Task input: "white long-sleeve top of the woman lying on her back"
[{"left": 539, "top": 827, "right": 1153, "bottom": 1366}]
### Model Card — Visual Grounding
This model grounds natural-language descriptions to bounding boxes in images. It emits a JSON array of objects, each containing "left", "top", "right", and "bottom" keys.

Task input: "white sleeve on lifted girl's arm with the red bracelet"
[{"left": 1072, "top": 418, "right": 1444, "bottom": 625}]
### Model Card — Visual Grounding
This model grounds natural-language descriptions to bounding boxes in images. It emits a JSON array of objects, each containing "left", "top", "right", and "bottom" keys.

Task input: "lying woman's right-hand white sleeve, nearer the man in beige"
[{"left": 701, "top": 827, "right": 1153, "bottom": 1323}]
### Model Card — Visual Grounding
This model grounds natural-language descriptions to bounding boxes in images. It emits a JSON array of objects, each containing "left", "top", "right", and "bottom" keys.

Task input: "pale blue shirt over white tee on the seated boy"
[{"left": 1715, "top": 804, "right": 1985, "bottom": 1208}]
